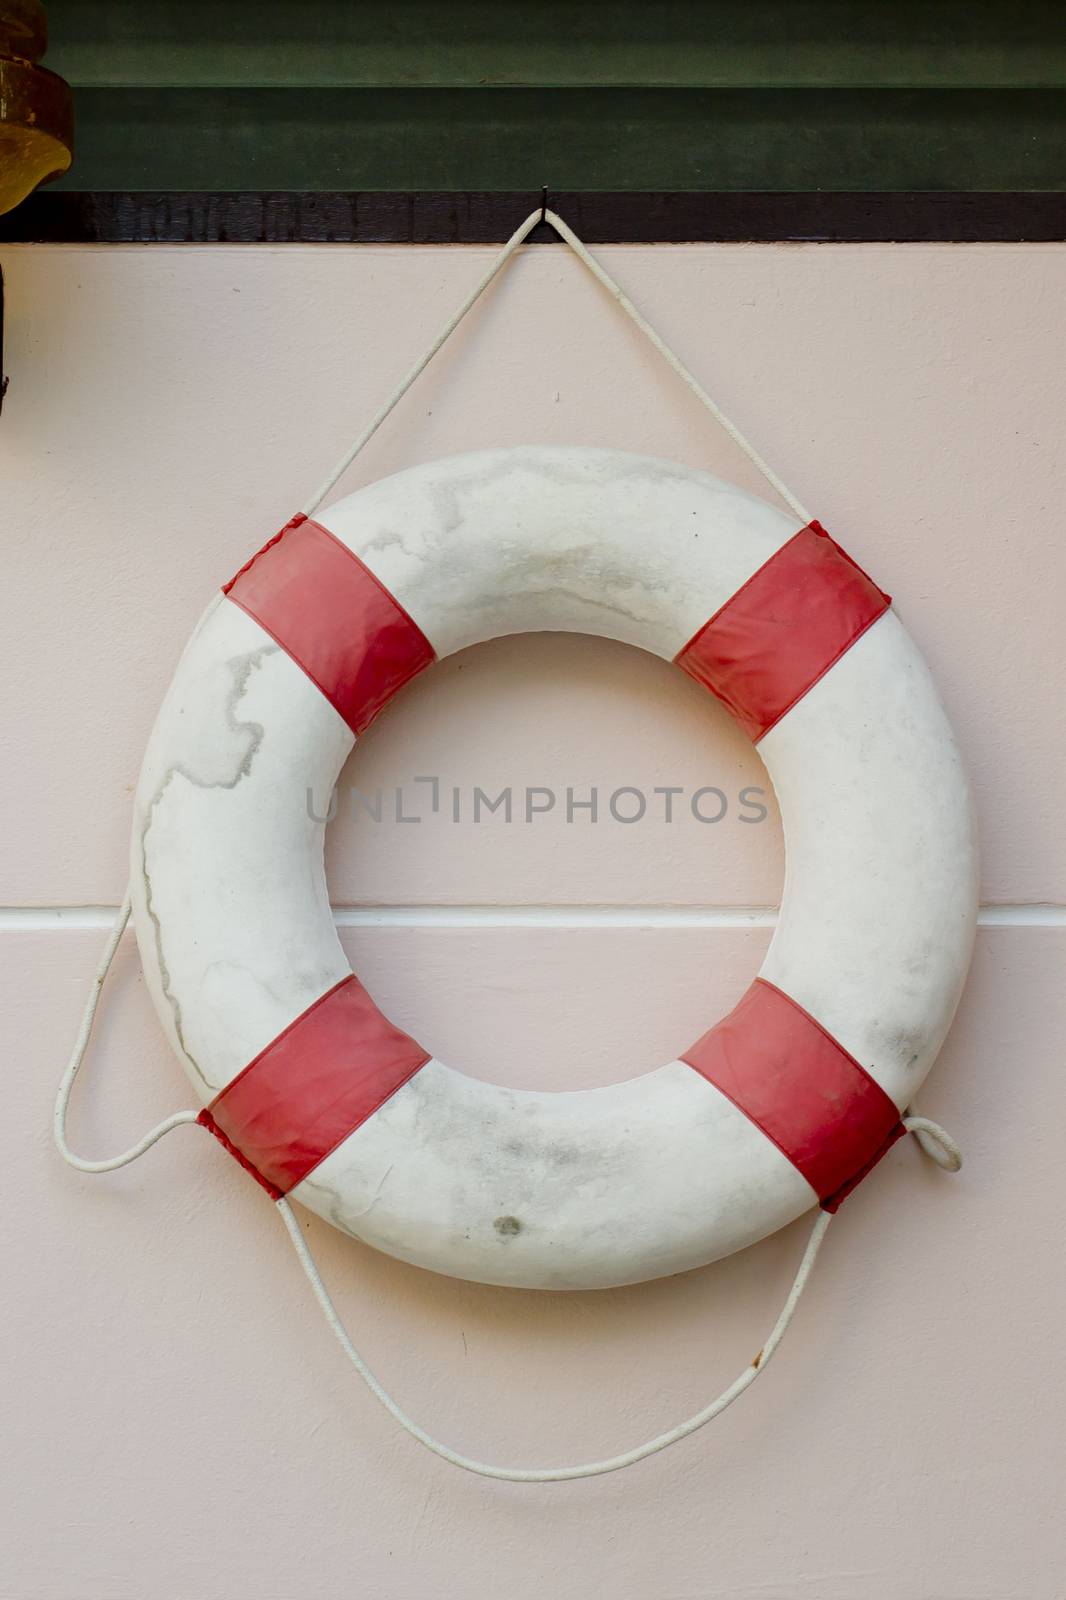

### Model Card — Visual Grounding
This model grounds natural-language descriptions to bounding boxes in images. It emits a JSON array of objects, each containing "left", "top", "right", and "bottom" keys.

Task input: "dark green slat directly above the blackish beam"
[{"left": 56, "top": 90, "right": 1066, "bottom": 190}]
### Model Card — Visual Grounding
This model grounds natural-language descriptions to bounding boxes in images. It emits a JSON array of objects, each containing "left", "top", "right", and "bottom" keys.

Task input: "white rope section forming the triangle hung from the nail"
[{"left": 304, "top": 206, "right": 812, "bottom": 523}]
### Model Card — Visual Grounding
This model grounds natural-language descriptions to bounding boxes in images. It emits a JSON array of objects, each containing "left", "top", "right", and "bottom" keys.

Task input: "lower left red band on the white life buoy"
[{"left": 198, "top": 974, "right": 429, "bottom": 1200}]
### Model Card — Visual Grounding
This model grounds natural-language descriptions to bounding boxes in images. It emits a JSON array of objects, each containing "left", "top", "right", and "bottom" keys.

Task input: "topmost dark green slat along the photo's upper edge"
[{"left": 48, "top": 0, "right": 1066, "bottom": 88}]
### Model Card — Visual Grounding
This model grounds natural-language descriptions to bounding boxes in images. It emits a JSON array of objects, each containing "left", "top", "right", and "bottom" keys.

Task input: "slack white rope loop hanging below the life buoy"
[{"left": 277, "top": 1200, "right": 832, "bottom": 1483}]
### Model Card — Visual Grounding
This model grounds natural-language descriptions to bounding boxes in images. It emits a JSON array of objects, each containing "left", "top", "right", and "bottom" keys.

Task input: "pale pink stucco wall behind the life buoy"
[{"left": 0, "top": 246, "right": 1066, "bottom": 1600}]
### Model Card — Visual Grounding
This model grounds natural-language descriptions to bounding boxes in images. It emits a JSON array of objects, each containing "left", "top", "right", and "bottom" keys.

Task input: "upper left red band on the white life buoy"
[{"left": 222, "top": 514, "right": 435, "bottom": 734}]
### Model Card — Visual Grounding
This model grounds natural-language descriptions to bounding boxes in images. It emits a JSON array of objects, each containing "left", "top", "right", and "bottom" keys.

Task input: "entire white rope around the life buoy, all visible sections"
[{"left": 53, "top": 208, "right": 962, "bottom": 1483}]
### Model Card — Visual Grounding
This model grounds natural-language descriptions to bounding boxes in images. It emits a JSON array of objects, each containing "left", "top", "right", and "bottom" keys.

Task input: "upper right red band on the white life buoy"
[{"left": 674, "top": 522, "right": 892, "bottom": 741}]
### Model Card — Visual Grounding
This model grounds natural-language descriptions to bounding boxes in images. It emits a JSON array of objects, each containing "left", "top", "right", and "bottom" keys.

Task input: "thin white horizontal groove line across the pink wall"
[{"left": 0, "top": 902, "right": 1066, "bottom": 933}]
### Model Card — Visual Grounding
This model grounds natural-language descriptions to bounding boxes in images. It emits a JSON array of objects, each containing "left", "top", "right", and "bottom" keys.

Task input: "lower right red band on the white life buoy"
[{"left": 680, "top": 978, "right": 904, "bottom": 1211}]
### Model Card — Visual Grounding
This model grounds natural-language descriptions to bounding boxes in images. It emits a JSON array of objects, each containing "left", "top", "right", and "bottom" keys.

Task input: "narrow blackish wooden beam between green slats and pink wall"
[{"left": 0, "top": 190, "right": 1066, "bottom": 245}]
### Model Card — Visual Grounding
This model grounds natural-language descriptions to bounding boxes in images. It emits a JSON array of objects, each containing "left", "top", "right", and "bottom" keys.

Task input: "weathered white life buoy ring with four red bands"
[{"left": 131, "top": 448, "right": 976, "bottom": 1288}]
